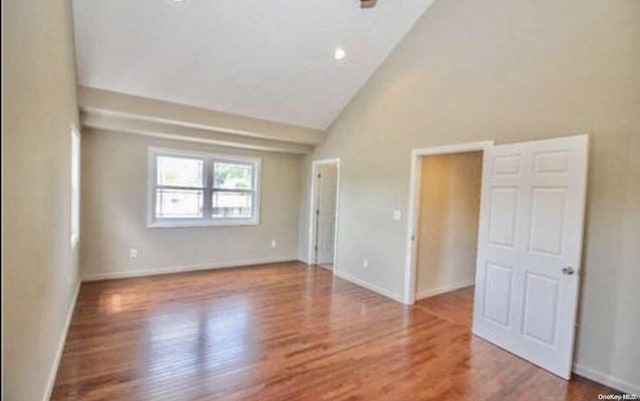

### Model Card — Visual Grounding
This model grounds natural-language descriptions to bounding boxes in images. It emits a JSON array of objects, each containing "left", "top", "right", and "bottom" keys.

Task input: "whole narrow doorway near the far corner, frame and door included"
[{"left": 309, "top": 159, "right": 340, "bottom": 271}]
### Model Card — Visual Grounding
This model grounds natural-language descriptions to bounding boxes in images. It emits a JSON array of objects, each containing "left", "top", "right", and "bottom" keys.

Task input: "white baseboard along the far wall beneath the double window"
[{"left": 82, "top": 256, "right": 298, "bottom": 282}]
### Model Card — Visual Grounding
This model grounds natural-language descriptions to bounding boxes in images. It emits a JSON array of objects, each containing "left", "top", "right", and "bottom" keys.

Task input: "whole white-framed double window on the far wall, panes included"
[{"left": 149, "top": 148, "right": 260, "bottom": 227}]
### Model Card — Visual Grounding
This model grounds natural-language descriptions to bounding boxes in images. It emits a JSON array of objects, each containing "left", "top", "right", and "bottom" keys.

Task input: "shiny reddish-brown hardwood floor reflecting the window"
[{"left": 52, "top": 263, "right": 612, "bottom": 401}]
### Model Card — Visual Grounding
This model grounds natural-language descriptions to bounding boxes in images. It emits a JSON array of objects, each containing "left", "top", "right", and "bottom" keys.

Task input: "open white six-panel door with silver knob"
[{"left": 473, "top": 135, "right": 588, "bottom": 379}]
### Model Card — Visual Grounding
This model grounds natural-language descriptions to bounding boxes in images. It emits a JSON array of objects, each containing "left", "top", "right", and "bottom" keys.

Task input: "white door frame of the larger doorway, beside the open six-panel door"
[{"left": 404, "top": 140, "right": 494, "bottom": 305}]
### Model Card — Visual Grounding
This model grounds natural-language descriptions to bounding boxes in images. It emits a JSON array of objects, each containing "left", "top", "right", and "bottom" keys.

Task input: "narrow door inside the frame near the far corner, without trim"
[{"left": 316, "top": 163, "right": 338, "bottom": 264}]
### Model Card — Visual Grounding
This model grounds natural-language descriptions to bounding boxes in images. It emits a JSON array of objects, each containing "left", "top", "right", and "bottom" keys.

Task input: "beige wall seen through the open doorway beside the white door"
[{"left": 416, "top": 152, "right": 482, "bottom": 298}]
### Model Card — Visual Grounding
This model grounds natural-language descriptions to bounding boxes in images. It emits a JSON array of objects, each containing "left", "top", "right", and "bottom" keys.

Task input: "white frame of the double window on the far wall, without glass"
[{"left": 147, "top": 147, "right": 262, "bottom": 228}]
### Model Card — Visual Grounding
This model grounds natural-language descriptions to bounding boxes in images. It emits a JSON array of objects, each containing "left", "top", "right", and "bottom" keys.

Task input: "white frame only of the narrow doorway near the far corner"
[{"left": 307, "top": 157, "right": 340, "bottom": 274}]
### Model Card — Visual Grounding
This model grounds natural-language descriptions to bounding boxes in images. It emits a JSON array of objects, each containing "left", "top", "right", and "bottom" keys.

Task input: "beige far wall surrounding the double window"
[{"left": 81, "top": 130, "right": 301, "bottom": 278}]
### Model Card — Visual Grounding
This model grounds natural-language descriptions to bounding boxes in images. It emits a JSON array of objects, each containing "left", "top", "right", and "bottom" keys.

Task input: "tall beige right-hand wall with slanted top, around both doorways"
[{"left": 299, "top": 0, "right": 640, "bottom": 392}]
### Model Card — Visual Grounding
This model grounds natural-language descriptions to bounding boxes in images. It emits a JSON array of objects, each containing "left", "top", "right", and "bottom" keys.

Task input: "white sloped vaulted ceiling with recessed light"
[{"left": 74, "top": 0, "right": 432, "bottom": 129}]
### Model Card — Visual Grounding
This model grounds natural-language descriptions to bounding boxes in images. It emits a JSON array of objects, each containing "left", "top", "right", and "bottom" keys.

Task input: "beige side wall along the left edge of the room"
[{"left": 2, "top": 0, "right": 78, "bottom": 401}]
